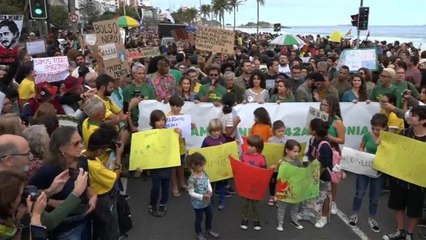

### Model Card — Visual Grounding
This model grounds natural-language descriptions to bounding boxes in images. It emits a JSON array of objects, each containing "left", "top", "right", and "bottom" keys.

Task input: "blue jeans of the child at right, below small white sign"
[{"left": 352, "top": 174, "right": 385, "bottom": 217}]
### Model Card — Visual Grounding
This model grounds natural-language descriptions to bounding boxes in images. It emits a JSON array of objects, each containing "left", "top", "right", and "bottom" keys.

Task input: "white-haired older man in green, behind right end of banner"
[{"left": 370, "top": 68, "right": 396, "bottom": 102}]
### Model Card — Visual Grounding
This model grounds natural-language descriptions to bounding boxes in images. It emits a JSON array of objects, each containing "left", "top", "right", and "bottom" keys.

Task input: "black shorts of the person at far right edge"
[{"left": 388, "top": 184, "right": 425, "bottom": 218}]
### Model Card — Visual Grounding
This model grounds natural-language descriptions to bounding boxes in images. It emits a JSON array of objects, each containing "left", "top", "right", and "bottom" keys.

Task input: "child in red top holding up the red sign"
[{"left": 240, "top": 135, "right": 266, "bottom": 231}]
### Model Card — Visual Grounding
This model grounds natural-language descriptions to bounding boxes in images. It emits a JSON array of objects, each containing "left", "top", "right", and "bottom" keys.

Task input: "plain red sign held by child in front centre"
[{"left": 229, "top": 157, "right": 273, "bottom": 200}]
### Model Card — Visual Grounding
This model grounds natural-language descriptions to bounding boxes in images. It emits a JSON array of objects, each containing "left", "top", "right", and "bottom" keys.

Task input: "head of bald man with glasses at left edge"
[{"left": 0, "top": 134, "right": 33, "bottom": 173}]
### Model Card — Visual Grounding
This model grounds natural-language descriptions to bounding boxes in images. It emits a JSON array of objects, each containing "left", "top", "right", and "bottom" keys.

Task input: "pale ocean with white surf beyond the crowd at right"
[{"left": 231, "top": 25, "right": 426, "bottom": 50}]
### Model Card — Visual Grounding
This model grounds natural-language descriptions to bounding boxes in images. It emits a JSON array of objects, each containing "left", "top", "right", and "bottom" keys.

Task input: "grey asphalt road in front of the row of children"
[{"left": 123, "top": 174, "right": 395, "bottom": 240}]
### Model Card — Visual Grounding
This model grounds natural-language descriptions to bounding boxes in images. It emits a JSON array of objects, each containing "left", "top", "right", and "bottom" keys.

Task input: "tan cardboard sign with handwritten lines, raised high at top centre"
[{"left": 195, "top": 26, "right": 235, "bottom": 53}]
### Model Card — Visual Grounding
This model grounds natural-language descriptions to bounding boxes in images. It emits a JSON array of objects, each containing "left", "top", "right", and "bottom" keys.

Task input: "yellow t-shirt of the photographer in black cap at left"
[{"left": 87, "top": 158, "right": 117, "bottom": 194}]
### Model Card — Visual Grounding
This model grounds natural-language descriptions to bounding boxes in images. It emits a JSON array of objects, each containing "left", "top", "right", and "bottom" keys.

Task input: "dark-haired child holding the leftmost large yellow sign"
[{"left": 148, "top": 109, "right": 180, "bottom": 217}]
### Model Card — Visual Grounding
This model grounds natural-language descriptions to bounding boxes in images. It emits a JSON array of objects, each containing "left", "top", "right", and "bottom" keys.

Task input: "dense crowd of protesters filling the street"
[{"left": 0, "top": 23, "right": 426, "bottom": 240}]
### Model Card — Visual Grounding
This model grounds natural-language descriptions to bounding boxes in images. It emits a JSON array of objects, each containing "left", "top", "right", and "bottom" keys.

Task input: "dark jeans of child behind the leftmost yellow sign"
[{"left": 149, "top": 171, "right": 170, "bottom": 208}]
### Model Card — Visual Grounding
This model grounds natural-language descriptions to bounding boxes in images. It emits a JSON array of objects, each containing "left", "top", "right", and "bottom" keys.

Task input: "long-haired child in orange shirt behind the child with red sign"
[{"left": 249, "top": 107, "right": 272, "bottom": 142}]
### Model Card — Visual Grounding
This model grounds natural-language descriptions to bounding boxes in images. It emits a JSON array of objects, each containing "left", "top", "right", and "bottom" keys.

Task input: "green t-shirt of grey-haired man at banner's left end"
[{"left": 123, "top": 82, "right": 157, "bottom": 126}]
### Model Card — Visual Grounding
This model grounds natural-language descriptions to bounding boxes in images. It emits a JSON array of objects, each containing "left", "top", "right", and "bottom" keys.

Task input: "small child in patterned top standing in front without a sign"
[{"left": 187, "top": 152, "right": 219, "bottom": 240}]
